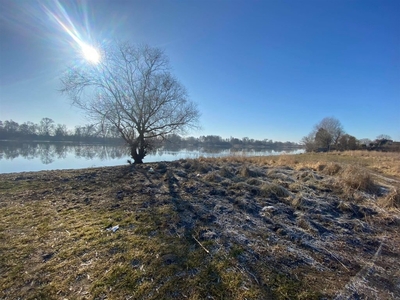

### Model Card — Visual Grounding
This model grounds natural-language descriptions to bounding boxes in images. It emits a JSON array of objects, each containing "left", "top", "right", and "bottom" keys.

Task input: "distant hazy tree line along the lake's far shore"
[{"left": 0, "top": 118, "right": 301, "bottom": 149}]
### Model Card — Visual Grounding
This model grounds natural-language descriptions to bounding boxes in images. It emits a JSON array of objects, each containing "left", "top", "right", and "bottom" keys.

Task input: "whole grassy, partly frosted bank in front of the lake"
[{"left": 0, "top": 151, "right": 400, "bottom": 299}]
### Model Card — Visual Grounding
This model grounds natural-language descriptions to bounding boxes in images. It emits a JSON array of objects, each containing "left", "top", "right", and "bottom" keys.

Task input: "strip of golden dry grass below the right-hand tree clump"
[{"left": 207, "top": 151, "right": 400, "bottom": 205}]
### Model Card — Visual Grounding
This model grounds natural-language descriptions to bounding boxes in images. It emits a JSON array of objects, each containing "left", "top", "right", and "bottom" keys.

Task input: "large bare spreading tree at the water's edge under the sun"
[{"left": 61, "top": 43, "right": 200, "bottom": 163}]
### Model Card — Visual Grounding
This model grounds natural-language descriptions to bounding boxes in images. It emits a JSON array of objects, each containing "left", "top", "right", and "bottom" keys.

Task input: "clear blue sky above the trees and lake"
[{"left": 0, "top": 0, "right": 400, "bottom": 142}]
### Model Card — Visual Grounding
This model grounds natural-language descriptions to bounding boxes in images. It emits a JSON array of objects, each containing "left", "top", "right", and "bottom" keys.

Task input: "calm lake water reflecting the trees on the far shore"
[{"left": 0, "top": 142, "right": 304, "bottom": 173}]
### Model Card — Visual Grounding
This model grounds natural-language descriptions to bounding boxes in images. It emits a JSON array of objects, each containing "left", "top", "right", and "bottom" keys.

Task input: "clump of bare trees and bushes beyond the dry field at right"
[{"left": 301, "top": 117, "right": 400, "bottom": 152}]
